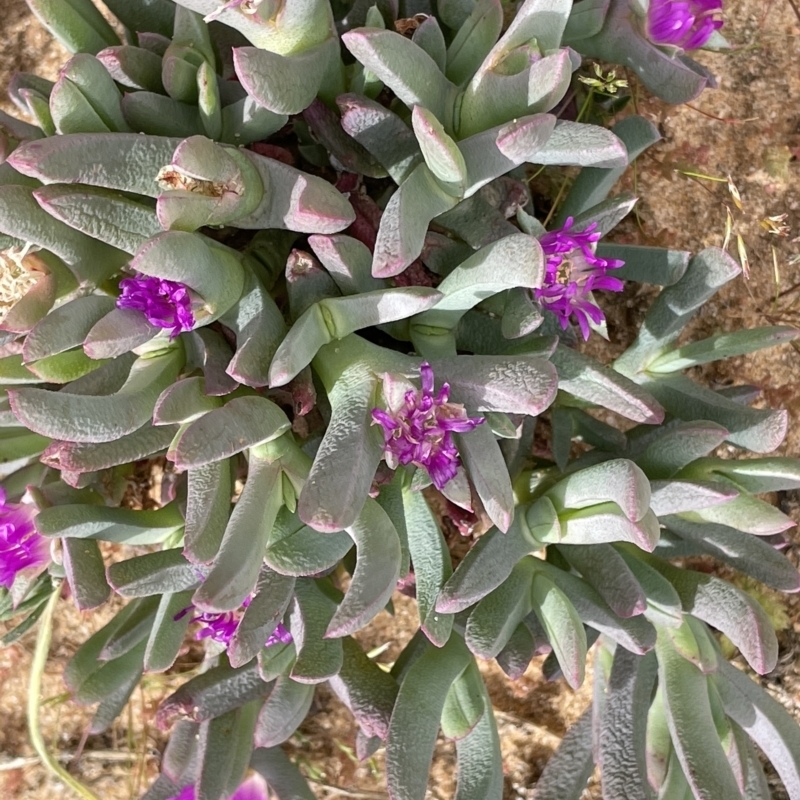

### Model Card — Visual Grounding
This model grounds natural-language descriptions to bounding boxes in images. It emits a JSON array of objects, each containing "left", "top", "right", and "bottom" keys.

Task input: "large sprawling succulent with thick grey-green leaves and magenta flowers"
[{"left": 0, "top": 0, "right": 800, "bottom": 800}]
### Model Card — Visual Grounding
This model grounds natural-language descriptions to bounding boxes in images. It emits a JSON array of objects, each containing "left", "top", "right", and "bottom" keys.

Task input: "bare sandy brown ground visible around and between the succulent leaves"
[{"left": 0, "top": 0, "right": 800, "bottom": 800}]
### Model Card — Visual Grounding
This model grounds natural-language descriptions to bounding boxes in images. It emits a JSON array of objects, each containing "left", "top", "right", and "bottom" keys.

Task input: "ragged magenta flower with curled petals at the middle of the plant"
[{"left": 372, "top": 363, "right": 484, "bottom": 489}]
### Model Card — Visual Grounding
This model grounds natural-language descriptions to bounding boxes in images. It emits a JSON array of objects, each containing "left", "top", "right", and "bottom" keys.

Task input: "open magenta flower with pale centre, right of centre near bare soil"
[{"left": 533, "top": 217, "right": 624, "bottom": 339}]
